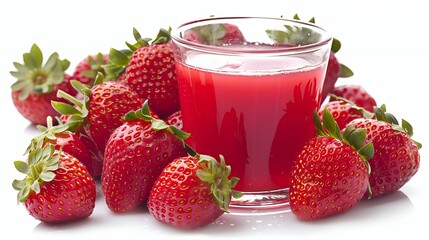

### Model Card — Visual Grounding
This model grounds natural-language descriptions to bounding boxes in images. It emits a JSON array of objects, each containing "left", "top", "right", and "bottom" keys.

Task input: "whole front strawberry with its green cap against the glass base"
[{"left": 148, "top": 156, "right": 240, "bottom": 229}]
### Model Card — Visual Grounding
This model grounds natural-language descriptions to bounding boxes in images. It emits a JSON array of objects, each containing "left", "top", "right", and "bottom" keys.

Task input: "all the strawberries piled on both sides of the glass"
[{"left": 11, "top": 16, "right": 421, "bottom": 229}]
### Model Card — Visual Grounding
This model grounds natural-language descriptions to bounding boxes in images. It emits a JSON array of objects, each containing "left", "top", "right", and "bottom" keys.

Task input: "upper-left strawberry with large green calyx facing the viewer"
[{"left": 10, "top": 44, "right": 75, "bottom": 125}]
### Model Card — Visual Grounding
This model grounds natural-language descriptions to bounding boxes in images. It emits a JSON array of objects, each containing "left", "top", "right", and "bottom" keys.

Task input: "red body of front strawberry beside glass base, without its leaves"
[{"left": 148, "top": 157, "right": 223, "bottom": 229}]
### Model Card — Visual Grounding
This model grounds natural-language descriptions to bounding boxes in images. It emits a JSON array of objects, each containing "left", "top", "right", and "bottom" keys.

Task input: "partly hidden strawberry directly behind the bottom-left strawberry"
[{"left": 25, "top": 117, "right": 94, "bottom": 176}]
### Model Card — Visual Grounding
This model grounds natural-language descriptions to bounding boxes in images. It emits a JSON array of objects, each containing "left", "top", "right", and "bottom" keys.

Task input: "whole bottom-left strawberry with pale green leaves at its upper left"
[{"left": 12, "top": 144, "right": 96, "bottom": 223}]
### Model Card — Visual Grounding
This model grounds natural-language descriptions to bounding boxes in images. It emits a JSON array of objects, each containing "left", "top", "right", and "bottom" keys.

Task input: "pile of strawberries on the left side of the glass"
[{"left": 12, "top": 26, "right": 241, "bottom": 228}]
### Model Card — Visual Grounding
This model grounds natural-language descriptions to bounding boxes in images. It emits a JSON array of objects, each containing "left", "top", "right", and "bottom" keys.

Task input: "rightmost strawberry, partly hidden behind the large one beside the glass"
[{"left": 348, "top": 105, "right": 422, "bottom": 197}]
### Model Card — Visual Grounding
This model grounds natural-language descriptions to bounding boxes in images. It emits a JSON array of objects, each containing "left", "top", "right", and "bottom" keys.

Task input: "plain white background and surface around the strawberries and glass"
[{"left": 0, "top": 0, "right": 429, "bottom": 239}]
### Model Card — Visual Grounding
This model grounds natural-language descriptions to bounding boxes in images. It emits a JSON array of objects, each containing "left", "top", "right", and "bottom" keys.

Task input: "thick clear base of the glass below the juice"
[{"left": 229, "top": 188, "right": 290, "bottom": 214}]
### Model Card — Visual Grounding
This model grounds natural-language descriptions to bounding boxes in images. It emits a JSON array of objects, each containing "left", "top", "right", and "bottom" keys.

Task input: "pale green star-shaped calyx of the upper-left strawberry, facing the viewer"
[{"left": 10, "top": 44, "right": 70, "bottom": 100}]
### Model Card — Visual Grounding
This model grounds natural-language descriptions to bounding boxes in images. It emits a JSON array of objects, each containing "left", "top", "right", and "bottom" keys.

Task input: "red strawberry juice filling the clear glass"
[{"left": 176, "top": 50, "right": 326, "bottom": 192}]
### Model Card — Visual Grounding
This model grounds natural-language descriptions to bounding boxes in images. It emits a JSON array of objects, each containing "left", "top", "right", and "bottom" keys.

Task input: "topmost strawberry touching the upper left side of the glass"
[{"left": 106, "top": 29, "right": 179, "bottom": 118}]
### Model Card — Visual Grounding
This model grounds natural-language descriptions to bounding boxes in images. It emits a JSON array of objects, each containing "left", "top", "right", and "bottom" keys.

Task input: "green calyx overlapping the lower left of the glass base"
[{"left": 197, "top": 155, "right": 243, "bottom": 212}]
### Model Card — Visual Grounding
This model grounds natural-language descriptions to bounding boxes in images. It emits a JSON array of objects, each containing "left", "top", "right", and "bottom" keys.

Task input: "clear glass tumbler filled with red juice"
[{"left": 172, "top": 17, "right": 332, "bottom": 208}]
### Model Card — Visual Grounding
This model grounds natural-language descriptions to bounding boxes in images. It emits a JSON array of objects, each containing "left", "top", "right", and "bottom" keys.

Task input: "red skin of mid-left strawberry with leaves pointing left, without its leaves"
[{"left": 84, "top": 81, "right": 143, "bottom": 153}]
